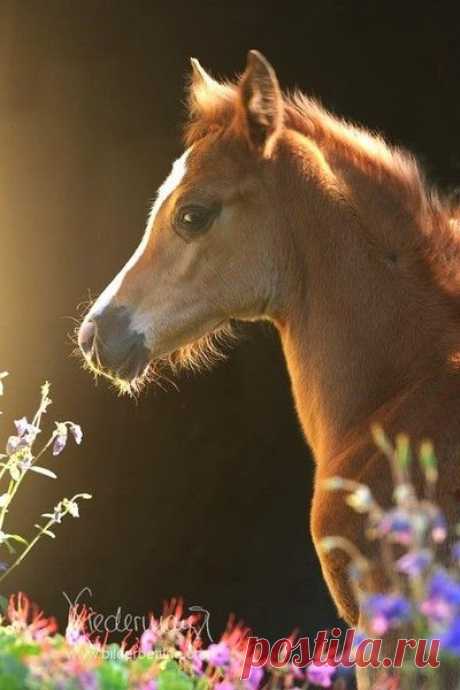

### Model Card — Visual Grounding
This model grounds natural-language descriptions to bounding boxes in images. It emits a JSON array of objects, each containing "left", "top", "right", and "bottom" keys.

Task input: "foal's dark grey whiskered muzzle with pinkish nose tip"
[{"left": 78, "top": 306, "right": 150, "bottom": 381}]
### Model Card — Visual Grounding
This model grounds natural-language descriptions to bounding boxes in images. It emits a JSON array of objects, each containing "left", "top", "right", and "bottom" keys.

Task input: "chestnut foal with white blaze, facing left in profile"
[{"left": 79, "top": 51, "right": 460, "bottom": 644}]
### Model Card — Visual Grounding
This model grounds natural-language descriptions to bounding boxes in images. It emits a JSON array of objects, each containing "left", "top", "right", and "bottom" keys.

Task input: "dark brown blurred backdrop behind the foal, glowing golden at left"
[{"left": 0, "top": 0, "right": 460, "bottom": 638}]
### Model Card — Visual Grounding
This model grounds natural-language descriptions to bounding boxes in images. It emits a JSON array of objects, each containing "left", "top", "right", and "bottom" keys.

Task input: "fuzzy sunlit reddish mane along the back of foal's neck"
[{"left": 284, "top": 91, "right": 460, "bottom": 298}]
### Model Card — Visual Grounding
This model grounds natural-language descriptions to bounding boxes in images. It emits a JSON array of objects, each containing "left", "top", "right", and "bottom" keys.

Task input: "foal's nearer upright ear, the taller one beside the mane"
[{"left": 239, "top": 50, "right": 283, "bottom": 156}]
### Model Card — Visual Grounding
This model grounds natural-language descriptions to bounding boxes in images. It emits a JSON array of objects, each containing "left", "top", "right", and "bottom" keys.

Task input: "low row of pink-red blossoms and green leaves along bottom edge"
[{"left": 0, "top": 594, "right": 344, "bottom": 690}]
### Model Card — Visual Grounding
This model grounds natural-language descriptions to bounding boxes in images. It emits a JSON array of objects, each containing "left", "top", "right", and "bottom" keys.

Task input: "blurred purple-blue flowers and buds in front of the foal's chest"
[{"left": 322, "top": 426, "right": 460, "bottom": 690}]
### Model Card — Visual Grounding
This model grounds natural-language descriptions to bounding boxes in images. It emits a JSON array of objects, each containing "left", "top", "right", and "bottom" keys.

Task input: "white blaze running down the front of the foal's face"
[{"left": 87, "top": 147, "right": 191, "bottom": 319}]
